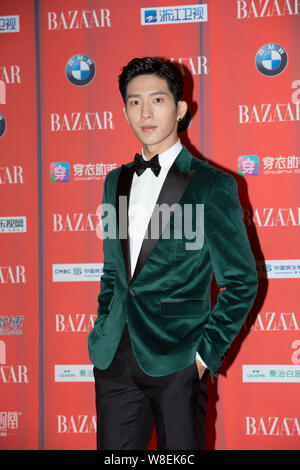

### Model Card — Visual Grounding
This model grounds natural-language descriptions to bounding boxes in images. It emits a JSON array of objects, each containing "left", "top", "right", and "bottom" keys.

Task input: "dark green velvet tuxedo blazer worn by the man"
[{"left": 88, "top": 147, "right": 257, "bottom": 376}]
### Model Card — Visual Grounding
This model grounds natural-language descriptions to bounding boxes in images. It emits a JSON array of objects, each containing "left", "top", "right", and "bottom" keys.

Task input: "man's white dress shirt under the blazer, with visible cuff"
[{"left": 128, "top": 139, "right": 206, "bottom": 367}]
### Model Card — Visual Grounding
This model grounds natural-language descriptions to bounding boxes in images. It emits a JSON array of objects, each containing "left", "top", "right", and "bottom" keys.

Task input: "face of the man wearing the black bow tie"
[{"left": 124, "top": 75, "right": 186, "bottom": 153}]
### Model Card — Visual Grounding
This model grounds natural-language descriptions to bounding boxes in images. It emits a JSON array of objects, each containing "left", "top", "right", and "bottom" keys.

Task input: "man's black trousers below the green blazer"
[{"left": 94, "top": 324, "right": 208, "bottom": 450}]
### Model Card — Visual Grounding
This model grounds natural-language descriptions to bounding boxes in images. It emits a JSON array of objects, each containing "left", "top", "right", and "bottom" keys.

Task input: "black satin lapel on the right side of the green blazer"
[{"left": 130, "top": 162, "right": 196, "bottom": 282}]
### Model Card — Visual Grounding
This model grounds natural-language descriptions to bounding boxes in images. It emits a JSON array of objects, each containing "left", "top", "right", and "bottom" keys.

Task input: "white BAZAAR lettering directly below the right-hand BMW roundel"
[{"left": 238, "top": 102, "right": 300, "bottom": 124}]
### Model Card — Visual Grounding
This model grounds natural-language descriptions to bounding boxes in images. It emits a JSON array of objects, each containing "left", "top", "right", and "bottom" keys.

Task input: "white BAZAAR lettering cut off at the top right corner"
[{"left": 236, "top": 0, "right": 299, "bottom": 19}]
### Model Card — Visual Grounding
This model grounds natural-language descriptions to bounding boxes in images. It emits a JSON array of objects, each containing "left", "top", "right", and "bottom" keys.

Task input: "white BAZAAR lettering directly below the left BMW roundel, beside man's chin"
[{"left": 50, "top": 111, "right": 114, "bottom": 132}]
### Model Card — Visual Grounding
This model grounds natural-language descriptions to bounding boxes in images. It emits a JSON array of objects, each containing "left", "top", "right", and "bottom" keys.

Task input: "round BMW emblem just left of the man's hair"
[{"left": 66, "top": 54, "right": 96, "bottom": 86}]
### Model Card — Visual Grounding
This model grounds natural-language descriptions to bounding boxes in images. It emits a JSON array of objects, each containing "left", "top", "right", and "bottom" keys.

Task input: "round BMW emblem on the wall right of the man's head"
[{"left": 255, "top": 43, "right": 287, "bottom": 77}]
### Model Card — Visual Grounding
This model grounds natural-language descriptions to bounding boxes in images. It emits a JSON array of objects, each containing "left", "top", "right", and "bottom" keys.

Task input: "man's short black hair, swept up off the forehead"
[{"left": 119, "top": 57, "right": 191, "bottom": 132}]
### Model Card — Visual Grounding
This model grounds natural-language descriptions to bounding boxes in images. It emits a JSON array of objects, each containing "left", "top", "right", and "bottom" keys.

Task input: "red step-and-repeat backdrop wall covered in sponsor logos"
[{"left": 0, "top": 0, "right": 300, "bottom": 450}]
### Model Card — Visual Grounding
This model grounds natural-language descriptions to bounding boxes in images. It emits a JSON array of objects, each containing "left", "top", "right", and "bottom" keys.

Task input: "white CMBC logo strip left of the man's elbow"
[{"left": 52, "top": 263, "right": 103, "bottom": 282}]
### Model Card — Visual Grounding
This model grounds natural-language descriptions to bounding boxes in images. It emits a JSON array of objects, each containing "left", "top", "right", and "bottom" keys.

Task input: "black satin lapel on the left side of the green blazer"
[{"left": 116, "top": 165, "right": 134, "bottom": 282}]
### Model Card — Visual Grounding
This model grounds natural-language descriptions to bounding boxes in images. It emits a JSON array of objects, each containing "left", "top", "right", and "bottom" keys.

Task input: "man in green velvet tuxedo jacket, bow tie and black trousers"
[{"left": 88, "top": 58, "right": 257, "bottom": 449}]
